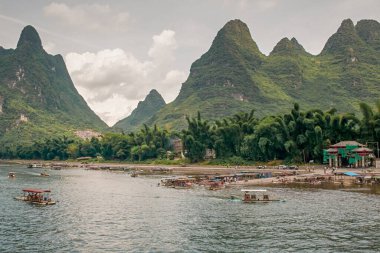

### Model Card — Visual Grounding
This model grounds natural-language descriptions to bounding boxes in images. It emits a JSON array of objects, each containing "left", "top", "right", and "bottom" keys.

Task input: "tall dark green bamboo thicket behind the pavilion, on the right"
[{"left": 183, "top": 102, "right": 380, "bottom": 162}]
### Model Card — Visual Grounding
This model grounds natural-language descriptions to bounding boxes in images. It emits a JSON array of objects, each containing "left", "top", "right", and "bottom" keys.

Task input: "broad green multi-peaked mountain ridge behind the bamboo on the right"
[{"left": 148, "top": 19, "right": 380, "bottom": 129}]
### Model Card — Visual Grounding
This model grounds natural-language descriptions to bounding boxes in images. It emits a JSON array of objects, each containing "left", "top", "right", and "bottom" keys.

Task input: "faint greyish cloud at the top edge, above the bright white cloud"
[{"left": 43, "top": 2, "right": 129, "bottom": 31}]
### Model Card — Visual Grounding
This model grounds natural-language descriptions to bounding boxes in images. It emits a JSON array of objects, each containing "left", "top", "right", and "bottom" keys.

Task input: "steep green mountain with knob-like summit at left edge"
[{"left": 0, "top": 26, "right": 107, "bottom": 145}]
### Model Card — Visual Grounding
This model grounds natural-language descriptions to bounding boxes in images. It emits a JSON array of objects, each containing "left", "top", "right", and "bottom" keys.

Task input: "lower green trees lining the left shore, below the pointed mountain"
[{"left": 0, "top": 125, "right": 173, "bottom": 161}]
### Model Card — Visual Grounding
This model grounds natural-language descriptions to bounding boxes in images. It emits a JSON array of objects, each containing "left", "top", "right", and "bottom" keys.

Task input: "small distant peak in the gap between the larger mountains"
[{"left": 113, "top": 89, "right": 166, "bottom": 132}]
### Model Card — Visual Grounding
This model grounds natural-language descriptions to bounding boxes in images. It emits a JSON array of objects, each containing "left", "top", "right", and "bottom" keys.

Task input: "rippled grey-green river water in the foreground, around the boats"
[{"left": 0, "top": 165, "right": 380, "bottom": 253}]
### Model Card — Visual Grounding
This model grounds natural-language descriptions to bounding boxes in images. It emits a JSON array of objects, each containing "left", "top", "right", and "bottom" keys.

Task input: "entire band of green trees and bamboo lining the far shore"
[{"left": 0, "top": 101, "right": 380, "bottom": 163}]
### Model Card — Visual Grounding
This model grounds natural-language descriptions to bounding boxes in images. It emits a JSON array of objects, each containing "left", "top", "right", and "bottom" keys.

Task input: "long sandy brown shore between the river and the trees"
[{"left": 0, "top": 160, "right": 380, "bottom": 194}]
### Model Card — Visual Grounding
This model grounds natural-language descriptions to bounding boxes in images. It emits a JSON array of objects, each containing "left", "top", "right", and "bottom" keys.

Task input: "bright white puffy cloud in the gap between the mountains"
[{"left": 66, "top": 30, "right": 186, "bottom": 124}]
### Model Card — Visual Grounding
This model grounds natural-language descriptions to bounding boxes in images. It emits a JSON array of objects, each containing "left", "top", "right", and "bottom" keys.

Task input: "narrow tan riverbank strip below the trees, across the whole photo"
[{"left": 0, "top": 160, "right": 380, "bottom": 191}]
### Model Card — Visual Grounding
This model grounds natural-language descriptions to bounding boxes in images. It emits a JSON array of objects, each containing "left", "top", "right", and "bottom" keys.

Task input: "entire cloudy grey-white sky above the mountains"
[{"left": 0, "top": 0, "right": 380, "bottom": 125}]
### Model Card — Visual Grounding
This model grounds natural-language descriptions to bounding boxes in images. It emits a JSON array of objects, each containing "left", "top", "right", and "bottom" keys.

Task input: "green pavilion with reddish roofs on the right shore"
[{"left": 323, "top": 141, "right": 374, "bottom": 168}]
